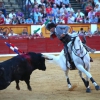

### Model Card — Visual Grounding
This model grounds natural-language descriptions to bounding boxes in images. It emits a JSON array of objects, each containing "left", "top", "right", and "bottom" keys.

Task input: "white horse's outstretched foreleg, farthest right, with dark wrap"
[{"left": 77, "top": 65, "right": 100, "bottom": 90}]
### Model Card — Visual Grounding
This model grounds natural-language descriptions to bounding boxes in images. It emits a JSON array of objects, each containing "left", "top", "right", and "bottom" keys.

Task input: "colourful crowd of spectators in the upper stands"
[{"left": 0, "top": 0, "right": 100, "bottom": 25}]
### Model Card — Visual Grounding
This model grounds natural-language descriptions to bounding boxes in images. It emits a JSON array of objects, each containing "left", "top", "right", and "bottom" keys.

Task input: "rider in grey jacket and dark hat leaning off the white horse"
[{"left": 46, "top": 22, "right": 95, "bottom": 69}]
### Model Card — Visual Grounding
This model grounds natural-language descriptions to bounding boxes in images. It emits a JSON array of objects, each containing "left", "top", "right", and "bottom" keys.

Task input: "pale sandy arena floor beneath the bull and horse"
[{"left": 0, "top": 58, "right": 100, "bottom": 100}]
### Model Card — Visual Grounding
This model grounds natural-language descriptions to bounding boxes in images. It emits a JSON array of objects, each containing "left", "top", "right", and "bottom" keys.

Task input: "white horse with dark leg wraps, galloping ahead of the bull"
[{"left": 46, "top": 33, "right": 100, "bottom": 93}]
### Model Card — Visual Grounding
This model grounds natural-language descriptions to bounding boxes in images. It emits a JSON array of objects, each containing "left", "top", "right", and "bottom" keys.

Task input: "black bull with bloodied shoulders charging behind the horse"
[{"left": 0, "top": 52, "right": 50, "bottom": 90}]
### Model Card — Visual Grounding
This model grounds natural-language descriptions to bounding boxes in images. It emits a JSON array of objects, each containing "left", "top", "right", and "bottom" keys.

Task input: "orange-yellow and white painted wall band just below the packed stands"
[{"left": 0, "top": 24, "right": 100, "bottom": 37}]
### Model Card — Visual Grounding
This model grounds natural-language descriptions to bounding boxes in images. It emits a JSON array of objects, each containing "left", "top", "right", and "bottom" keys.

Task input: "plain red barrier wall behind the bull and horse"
[{"left": 0, "top": 36, "right": 100, "bottom": 54}]
